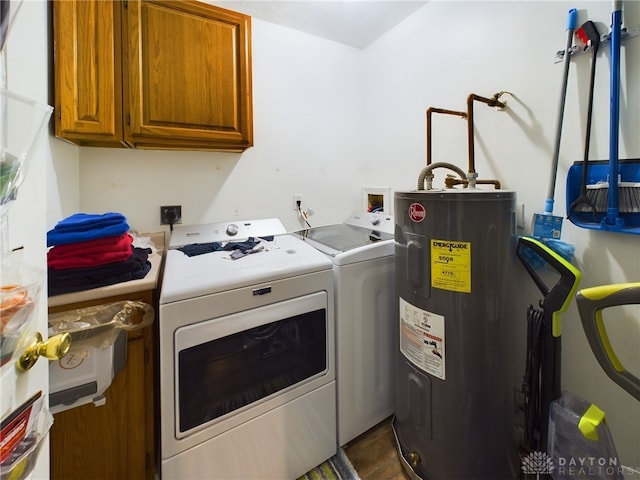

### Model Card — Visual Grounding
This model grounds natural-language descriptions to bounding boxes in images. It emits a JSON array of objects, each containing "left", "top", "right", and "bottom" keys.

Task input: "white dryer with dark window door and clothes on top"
[{"left": 158, "top": 219, "right": 337, "bottom": 480}]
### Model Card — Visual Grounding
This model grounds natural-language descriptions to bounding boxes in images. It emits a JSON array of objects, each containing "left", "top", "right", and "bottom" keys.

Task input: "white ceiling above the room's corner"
[{"left": 209, "top": 0, "right": 427, "bottom": 48}]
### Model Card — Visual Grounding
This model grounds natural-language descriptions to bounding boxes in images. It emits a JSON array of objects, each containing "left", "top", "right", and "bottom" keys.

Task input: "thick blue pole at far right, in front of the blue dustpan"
[{"left": 606, "top": 0, "right": 622, "bottom": 225}]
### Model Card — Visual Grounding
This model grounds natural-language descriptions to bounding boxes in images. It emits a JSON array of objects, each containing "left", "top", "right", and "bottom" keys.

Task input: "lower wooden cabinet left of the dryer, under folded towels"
[{"left": 49, "top": 291, "right": 157, "bottom": 480}]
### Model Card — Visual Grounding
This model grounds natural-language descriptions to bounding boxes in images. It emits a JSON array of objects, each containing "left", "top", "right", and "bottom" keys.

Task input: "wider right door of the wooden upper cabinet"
[{"left": 123, "top": 0, "right": 253, "bottom": 151}]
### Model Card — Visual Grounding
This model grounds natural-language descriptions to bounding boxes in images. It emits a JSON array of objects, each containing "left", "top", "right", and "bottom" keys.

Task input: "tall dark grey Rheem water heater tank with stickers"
[{"left": 393, "top": 189, "right": 524, "bottom": 480}]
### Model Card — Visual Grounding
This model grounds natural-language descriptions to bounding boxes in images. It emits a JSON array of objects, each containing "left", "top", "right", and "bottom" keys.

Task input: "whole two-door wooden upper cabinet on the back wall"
[{"left": 54, "top": 0, "right": 253, "bottom": 151}]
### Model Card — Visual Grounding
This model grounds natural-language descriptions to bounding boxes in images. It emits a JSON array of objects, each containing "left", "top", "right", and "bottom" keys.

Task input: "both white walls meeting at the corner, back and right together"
[{"left": 53, "top": 1, "right": 640, "bottom": 469}]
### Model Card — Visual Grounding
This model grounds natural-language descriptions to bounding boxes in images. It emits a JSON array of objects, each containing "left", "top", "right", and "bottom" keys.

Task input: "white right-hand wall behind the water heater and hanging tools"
[{"left": 363, "top": 1, "right": 640, "bottom": 469}]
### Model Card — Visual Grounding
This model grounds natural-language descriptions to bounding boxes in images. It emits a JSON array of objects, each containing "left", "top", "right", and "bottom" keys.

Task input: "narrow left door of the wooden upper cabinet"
[{"left": 53, "top": 0, "right": 123, "bottom": 146}]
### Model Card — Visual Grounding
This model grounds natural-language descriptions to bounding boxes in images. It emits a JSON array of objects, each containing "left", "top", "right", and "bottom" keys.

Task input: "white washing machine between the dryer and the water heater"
[{"left": 294, "top": 212, "right": 398, "bottom": 445}]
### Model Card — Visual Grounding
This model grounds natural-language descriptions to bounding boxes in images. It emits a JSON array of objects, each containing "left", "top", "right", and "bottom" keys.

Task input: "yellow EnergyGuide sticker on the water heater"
[{"left": 431, "top": 239, "right": 471, "bottom": 293}]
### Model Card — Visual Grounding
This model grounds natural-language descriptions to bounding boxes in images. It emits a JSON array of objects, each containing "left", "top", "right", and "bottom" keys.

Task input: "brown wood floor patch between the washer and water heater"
[{"left": 342, "top": 417, "right": 410, "bottom": 480}]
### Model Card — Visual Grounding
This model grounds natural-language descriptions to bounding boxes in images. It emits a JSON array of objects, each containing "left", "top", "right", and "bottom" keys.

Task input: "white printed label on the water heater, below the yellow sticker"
[{"left": 400, "top": 298, "right": 445, "bottom": 380}]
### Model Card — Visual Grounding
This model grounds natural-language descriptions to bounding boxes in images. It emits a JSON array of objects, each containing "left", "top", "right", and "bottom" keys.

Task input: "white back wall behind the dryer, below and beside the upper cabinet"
[{"left": 61, "top": 19, "right": 364, "bottom": 231}]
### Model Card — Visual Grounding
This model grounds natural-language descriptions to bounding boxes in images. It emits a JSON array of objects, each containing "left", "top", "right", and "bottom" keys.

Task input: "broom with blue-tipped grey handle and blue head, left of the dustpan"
[{"left": 530, "top": 8, "right": 578, "bottom": 269}]
